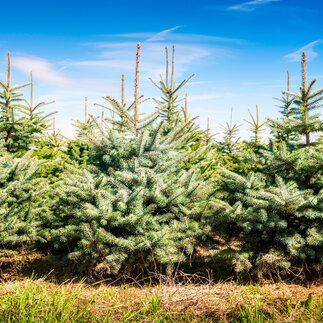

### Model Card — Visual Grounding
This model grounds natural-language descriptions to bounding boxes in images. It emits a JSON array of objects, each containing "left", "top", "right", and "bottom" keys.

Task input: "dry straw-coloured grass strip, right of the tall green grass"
[{"left": 78, "top": 283, "right": 323, "bottom": 322}]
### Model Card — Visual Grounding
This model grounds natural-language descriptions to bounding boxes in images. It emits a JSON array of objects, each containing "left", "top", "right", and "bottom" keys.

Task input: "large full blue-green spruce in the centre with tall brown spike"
[{"left": 52, "top": 45, "right": 212, "bottom": 272}]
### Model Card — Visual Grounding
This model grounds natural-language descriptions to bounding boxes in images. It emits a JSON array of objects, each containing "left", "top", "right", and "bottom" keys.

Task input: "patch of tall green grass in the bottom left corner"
[{"left": 0, "top": 281, "right": 95, "bottom": 322}]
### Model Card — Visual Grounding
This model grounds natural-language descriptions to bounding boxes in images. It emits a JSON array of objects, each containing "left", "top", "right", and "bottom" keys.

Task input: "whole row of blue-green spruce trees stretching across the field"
[{"left": 0, "top": 45, "right": 323, "bottom": 273}]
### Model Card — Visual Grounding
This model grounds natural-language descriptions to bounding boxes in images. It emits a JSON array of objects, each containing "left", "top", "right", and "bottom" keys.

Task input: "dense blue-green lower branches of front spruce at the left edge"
[{"left": 0, "top": 153, "right": 49, "bottom": 253}]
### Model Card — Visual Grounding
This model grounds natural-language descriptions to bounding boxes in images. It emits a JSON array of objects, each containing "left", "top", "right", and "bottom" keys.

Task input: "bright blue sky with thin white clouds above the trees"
[{"left": 0, "top": 0, "right": 323, "bottom": 137}]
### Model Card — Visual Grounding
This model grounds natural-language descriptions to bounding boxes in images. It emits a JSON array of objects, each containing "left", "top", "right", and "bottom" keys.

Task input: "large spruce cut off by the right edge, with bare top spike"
[{"left": 210, "top": 54, "right": 323, "bottom": 271}]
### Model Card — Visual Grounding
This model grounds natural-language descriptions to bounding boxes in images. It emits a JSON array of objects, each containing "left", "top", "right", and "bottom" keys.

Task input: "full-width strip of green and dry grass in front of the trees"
[{"left": 0, "top": 279, "right": 323, "bottom": 322}]
